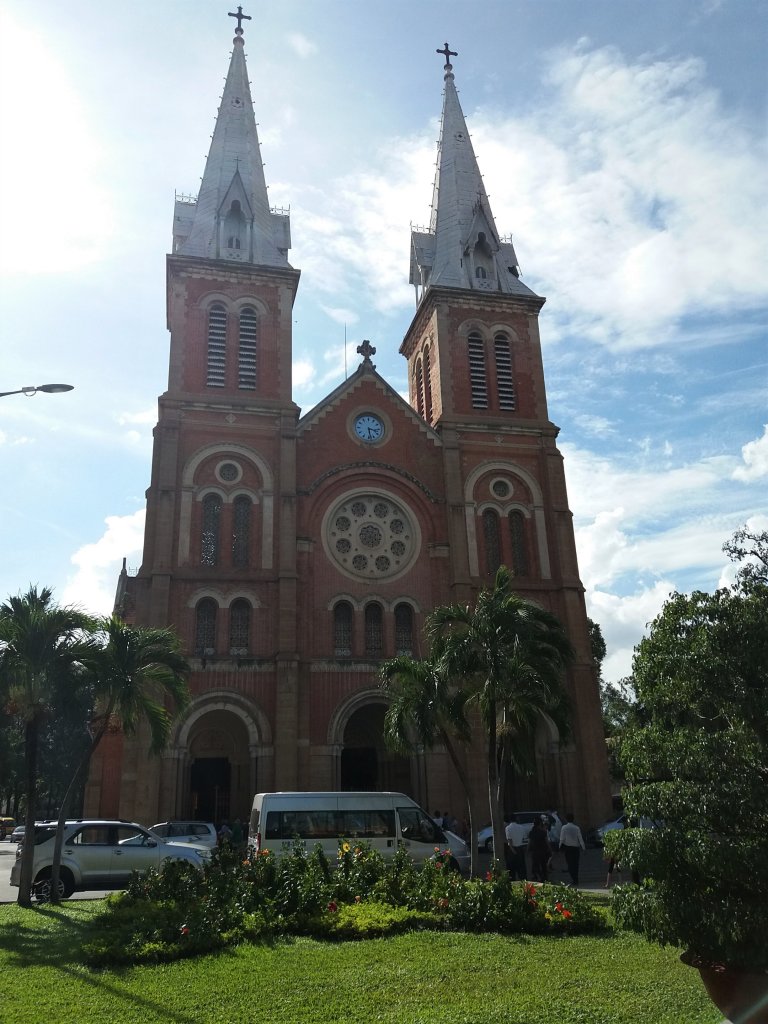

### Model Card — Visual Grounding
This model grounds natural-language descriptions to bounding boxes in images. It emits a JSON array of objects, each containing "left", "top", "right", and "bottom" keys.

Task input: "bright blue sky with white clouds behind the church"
[{"left": 0, "top": 0, "right": 768, "bottom": 682}]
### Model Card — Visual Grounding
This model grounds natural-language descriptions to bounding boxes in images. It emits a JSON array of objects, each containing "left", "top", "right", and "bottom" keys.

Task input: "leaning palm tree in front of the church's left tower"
[{"left": 46, "top": 615, "right": 189, "bottom": 900}]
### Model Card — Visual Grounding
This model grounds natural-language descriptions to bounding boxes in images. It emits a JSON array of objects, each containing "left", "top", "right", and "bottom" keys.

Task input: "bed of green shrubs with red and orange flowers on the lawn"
[{"left": 83, "top": 841, "right": 605, "bottom": 966}]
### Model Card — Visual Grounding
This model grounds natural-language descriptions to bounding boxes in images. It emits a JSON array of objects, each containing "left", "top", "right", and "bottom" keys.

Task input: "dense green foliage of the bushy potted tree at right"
[{"left": 606, "top": 535, "right": 768, "bottom": 967}]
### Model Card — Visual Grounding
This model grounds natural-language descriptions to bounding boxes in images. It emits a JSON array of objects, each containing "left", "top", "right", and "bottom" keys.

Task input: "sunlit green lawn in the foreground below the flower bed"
[{"left": 0, "top": 900, "right": 721, "bottom": 1024}]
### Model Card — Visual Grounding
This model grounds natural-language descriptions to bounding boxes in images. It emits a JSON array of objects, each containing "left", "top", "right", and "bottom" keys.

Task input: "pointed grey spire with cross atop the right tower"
[{"left": 411, "top": 43, "right": 532, "bottom": 298}]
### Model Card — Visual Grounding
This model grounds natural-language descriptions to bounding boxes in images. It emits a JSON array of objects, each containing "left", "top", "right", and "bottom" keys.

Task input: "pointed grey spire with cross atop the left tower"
[{"left": 175, "top": 7, "right": 290, "bottom": 266}]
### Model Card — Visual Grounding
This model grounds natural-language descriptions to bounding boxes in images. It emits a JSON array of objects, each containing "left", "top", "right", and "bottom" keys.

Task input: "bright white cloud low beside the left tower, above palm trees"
[{"left": 61, "top": 509, "right": 144, "bottom": 615}]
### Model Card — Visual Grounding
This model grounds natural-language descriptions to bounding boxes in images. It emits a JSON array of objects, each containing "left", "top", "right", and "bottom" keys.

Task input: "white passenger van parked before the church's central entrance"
[{"left": 248, "top": 793, "right": 470, "bottom": 876}]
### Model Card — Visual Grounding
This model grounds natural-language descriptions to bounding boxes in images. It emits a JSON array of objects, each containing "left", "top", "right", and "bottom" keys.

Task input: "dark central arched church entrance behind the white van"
[{"left": 339, "top": 702, "right": 414, "bottom": 795}]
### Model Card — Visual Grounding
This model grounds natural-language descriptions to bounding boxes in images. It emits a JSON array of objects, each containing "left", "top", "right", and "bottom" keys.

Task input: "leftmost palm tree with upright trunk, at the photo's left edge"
[{"left": 0, "top": 587, "right": 92, "bottom": 906}]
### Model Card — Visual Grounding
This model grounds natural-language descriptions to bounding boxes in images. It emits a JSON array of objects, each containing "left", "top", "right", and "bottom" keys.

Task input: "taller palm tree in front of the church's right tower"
[{"left": 425, "top": 565, "right": 573, "bottom": 868}]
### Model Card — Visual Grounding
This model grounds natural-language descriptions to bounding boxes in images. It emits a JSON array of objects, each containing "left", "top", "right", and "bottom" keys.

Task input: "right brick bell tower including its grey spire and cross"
[{"left": 400, "top": 43, "right": 609, "bottom": 819}]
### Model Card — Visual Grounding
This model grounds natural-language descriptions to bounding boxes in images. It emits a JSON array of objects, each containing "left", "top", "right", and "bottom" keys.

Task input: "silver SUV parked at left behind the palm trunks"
[{"left": 10, "top": 818, "right": 204, "bottom": 900}]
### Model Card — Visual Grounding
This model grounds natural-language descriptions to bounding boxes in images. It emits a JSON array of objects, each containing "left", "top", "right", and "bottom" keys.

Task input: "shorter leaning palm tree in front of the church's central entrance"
[{"left": 381, "top": 645, "right": 477, "bottom": 877}]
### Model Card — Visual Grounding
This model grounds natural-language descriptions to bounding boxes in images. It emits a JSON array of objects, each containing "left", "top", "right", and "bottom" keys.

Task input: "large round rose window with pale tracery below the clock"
[{"left": 324, "top": 494, "right": 420, "bottom": 579}]
